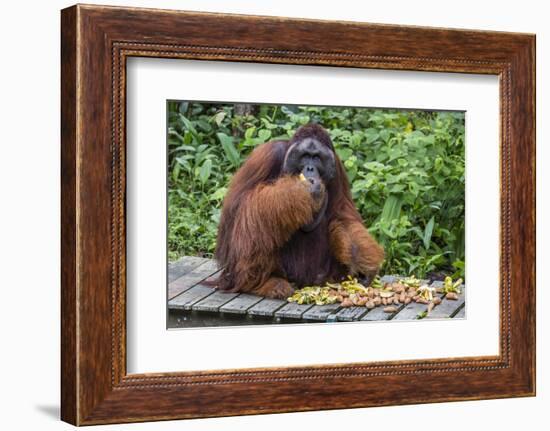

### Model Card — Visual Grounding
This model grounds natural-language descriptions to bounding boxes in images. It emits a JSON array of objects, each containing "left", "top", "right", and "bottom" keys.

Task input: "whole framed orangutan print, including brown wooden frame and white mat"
[{"left": 61, "top": 5, "right": 535, "bottom": 425}]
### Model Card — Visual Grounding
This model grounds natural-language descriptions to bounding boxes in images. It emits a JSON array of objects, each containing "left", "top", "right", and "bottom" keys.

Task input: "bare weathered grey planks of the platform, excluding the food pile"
[{"left": 168, "top": 256, "right": 465, "bottom": 327}]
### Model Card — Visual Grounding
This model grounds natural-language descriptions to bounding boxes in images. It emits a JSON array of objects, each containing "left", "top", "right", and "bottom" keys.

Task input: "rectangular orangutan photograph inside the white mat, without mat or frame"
[{"left": 166, "top": 101, "right": 468, "bottom": 328}]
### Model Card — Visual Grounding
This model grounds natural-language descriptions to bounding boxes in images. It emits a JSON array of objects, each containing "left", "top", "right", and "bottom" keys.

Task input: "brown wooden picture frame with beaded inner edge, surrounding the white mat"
[{"left": 61, "top": 5, "right": 535, "bottom": 425}]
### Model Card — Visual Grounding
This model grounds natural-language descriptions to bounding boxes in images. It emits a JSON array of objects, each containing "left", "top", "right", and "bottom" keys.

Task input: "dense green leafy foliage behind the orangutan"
[{"left": 168, "top": 102, "right": 465, "bottom": 277}]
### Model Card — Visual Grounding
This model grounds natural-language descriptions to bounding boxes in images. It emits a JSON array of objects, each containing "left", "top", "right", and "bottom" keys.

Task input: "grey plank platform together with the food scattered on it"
[{"left": 168, "top": 257, "right": 465, "bottom": 328}]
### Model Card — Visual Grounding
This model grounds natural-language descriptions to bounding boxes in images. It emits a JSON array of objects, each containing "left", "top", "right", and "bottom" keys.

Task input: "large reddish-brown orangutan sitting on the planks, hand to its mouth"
[{"left": 216, "top": 124, "right": 384, "bottom": 298}]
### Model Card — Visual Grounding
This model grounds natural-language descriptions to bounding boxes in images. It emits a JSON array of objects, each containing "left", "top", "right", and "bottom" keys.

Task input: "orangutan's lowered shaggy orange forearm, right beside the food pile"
[{"left": 329, "top": 218, "right": 384, "bottom": 277}]
